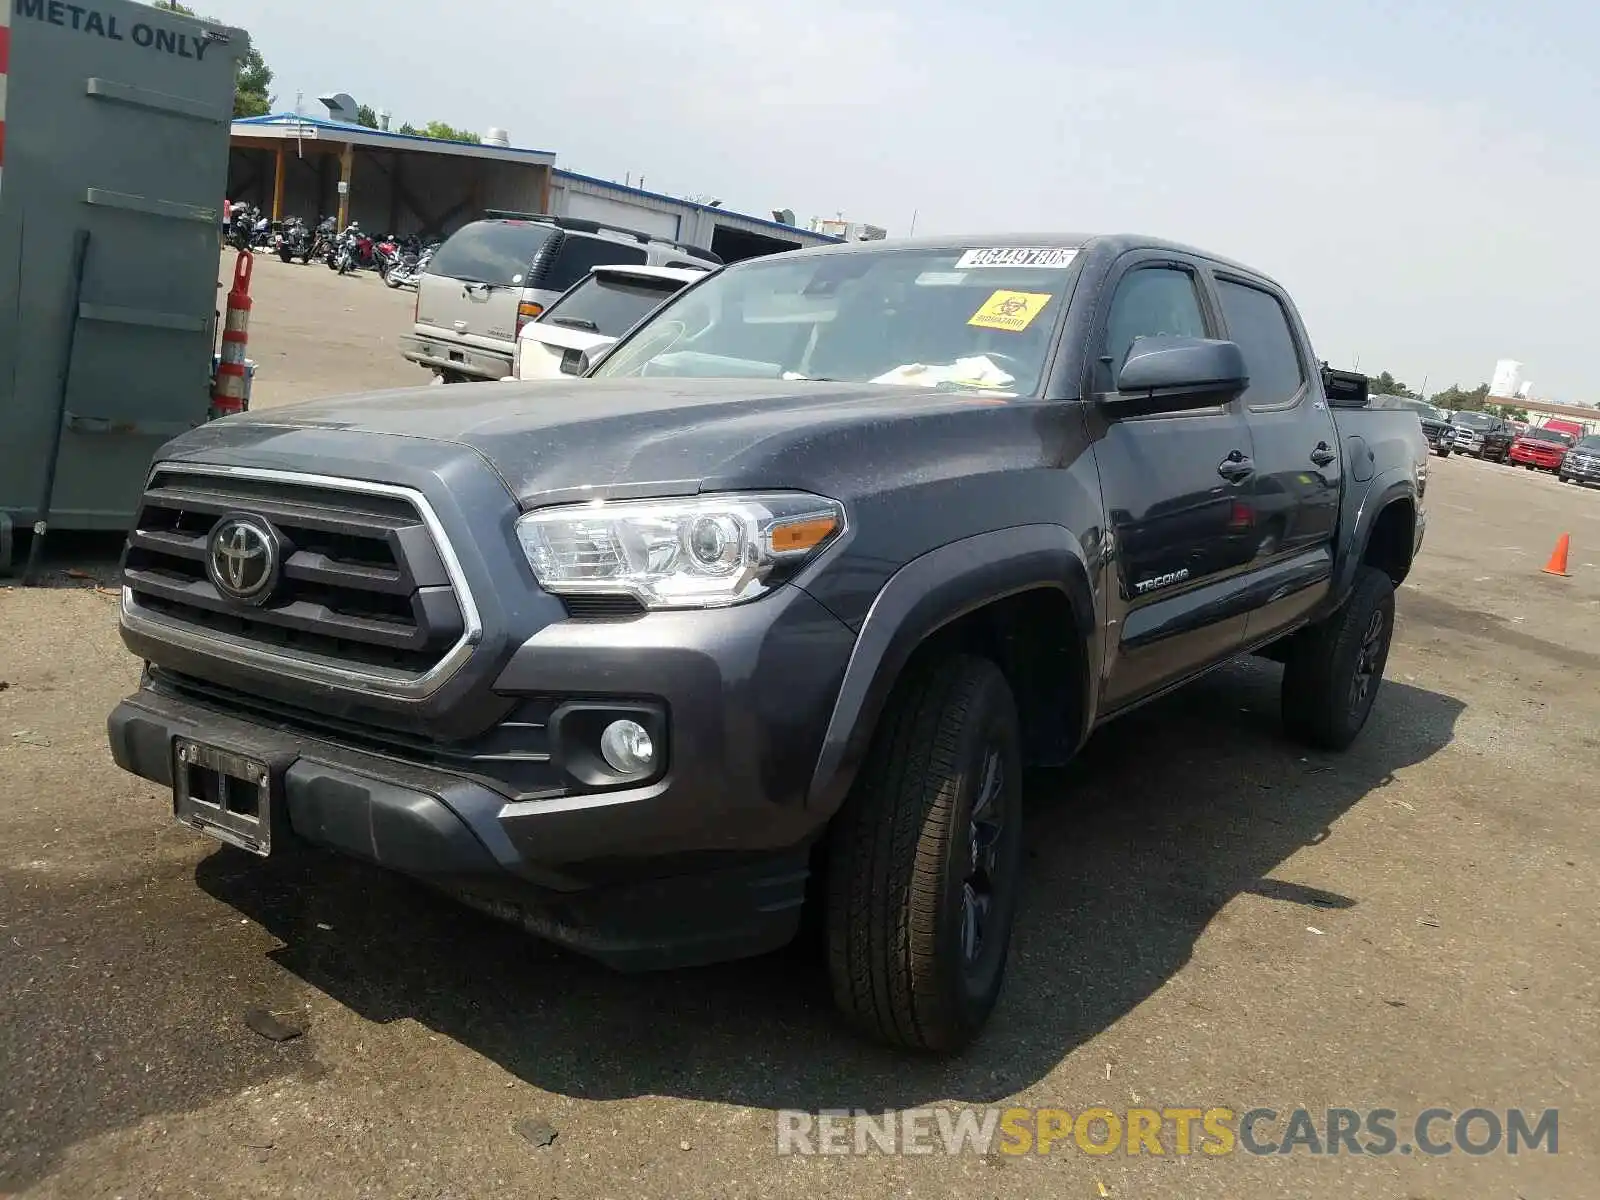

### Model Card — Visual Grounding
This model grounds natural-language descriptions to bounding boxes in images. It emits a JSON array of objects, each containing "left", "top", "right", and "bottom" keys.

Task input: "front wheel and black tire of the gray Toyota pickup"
[{"left": 824, "top": 654, "right": 1022, "bottom": 1051}]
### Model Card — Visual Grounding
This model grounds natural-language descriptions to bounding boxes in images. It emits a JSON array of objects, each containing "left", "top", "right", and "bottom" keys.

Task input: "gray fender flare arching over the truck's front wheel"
[{"left": 806, "top": 525, "right": 1099, "bottom": 816}]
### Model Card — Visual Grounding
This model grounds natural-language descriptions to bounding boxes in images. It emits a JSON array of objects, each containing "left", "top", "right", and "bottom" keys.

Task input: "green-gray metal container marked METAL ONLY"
[{"left": 0, "top": 0, "right": 250, "bottom": 568}]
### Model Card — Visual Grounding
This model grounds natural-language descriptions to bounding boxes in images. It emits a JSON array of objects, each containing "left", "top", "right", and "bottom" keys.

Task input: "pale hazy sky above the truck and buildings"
[{"left": 198, "top": 0, "right": 1600, "bottom": 400}]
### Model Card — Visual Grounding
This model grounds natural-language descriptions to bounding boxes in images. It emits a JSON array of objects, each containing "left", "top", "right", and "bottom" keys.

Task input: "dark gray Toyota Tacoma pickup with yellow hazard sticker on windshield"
[{"left": 109, "top": 235, "right": 1427, "bottom": 1050}]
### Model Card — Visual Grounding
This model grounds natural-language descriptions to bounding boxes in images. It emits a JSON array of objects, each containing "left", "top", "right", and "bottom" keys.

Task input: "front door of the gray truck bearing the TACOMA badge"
[{"left": 1088, "top": 251, "right": 1256, "bottom": 712}]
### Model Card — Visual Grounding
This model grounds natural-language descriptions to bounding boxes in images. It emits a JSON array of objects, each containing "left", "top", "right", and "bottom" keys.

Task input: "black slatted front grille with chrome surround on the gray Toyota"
[{"left": 123, "top": 467, "right": 477, "bottom": 686}]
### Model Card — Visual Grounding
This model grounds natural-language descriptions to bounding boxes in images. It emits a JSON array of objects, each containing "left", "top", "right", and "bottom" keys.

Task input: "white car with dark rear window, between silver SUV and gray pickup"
[{"left": 506, "top": 264, "right": 710, "bottom": 381}]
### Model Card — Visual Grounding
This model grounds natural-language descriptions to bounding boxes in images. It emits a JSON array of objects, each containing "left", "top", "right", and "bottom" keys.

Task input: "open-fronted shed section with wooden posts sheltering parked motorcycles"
[{"left": 227, "top": 112, "right": 555, "bottom": 237}]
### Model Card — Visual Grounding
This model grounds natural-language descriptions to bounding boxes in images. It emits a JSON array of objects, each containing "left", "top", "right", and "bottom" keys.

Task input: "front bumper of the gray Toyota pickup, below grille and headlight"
[{"left": 109, "top": 587, "right": 854, "bottom": 970}]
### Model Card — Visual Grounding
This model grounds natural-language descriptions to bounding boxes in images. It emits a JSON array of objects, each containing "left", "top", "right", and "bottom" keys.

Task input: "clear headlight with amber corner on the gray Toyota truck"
[{"left": 517, "top": 491, "right": 845, "bottom": 608}]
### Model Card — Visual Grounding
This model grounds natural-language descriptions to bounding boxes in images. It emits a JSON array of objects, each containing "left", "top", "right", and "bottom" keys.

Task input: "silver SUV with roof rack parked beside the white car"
[{"left": 400, "top": 211, "right": 722, "bottom": 384}]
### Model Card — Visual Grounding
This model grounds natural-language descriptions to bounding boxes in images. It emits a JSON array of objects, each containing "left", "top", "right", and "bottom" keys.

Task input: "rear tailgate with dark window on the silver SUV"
[{"left": 416, "top": 221, "right": 555, "bottom": 347}]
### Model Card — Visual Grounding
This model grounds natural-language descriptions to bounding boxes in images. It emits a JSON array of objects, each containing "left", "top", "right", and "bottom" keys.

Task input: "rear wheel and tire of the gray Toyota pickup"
[{"left": 1283, "top": 566, "right": 1395, "bottom": 750}]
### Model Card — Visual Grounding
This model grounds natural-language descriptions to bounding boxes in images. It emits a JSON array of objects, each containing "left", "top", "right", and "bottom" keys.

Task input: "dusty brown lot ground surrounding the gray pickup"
[{"left": 0, "top": 261, "right": 1600, "bottom": 1200}]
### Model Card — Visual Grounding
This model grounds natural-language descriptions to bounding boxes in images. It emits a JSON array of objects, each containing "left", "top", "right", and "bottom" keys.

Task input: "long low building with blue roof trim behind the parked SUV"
[{"left": 227, "top": 112, "right": 840, "bottom": 262}]
